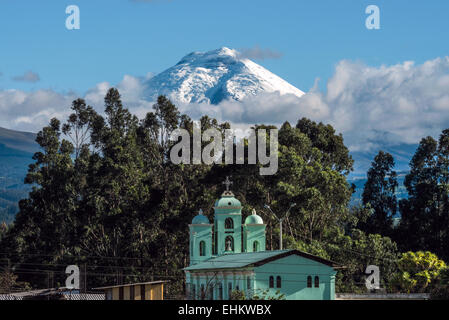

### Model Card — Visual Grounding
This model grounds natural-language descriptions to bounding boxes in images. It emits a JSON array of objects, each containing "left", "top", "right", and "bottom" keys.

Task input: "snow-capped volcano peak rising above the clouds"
[{"left": 145, "top": 47, "right": 304, "bottom": 104}]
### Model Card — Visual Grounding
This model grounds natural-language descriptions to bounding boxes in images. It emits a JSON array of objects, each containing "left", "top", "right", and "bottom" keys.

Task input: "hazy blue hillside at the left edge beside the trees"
[{"left": 0, "top": 128, "right": 39, "bottom": 223}]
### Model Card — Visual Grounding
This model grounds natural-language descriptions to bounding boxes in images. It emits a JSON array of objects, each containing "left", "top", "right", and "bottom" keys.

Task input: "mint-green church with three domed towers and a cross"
[{"left": 184, "top": 180, "right": 337, "bottom": 300}]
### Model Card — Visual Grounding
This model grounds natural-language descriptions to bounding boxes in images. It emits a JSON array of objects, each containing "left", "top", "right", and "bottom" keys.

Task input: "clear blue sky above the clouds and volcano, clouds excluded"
[{"left": 0, "top": 0, "right": 449, "bottom": 94}]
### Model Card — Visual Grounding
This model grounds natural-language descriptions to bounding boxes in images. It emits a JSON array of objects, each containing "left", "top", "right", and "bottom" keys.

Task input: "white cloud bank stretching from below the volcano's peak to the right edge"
[{"left": 184, "top": 57, "right": 449, "bottom": 152}]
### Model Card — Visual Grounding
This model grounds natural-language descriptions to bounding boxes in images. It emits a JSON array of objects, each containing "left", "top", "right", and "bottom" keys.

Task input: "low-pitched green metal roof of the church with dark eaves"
[{"left": 184, "top": 250, "right": 337, "bottom": 271}]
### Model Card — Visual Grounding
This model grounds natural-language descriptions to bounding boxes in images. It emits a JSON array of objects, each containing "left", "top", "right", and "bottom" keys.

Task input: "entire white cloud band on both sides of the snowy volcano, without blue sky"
[{"left": 0, "top": 57, "right": 449, "bottom": 159}]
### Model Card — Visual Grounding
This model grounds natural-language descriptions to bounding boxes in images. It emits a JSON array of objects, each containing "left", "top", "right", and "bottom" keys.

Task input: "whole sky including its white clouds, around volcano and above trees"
[{"left": 0, "top": 0, "right": 449, "bottom": 175}]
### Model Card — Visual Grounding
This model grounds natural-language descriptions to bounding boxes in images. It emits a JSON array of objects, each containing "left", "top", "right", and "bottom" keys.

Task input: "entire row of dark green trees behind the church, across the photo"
[{"left": 4, "top": 88, "right": 449, "bottom": 295}]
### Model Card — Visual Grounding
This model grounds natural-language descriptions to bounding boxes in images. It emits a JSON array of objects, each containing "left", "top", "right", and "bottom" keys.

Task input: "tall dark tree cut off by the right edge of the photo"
[{"left": 398, "top": 130, "right": 449, "bottom": 259}]
